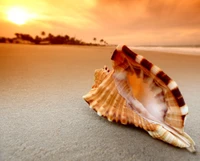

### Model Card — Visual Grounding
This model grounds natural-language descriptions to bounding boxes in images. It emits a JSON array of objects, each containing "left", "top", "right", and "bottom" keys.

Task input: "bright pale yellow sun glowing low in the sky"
[{"left": 7, "top": 7, "right": 30, "bottom": 25}]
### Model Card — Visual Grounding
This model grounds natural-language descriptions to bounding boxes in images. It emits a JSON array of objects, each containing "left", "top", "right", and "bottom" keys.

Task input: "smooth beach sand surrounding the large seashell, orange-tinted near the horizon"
[{"left": 0, "top": 44, "right": 200, "bottom": 161}]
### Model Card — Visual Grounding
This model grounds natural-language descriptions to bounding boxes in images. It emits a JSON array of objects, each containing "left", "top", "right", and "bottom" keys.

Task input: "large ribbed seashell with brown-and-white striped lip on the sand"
[{"left": 83, "top": 45, "right": 195, "bottom": 152}]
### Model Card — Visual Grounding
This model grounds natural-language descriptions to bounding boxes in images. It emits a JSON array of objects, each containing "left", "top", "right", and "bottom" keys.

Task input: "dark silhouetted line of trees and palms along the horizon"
[{"left": 0, "top": 31, "right": 108, "bottom": 45}]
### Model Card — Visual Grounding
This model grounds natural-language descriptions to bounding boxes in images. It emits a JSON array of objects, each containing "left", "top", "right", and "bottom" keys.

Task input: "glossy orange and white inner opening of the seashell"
[{"left": 114, "top": 71, "right": 167, "bottom": 122}]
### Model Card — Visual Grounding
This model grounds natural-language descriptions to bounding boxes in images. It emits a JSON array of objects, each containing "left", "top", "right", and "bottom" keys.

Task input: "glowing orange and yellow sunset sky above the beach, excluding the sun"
[{"left": 0, "top": 0, "right": 200, "bottom": 46}]
